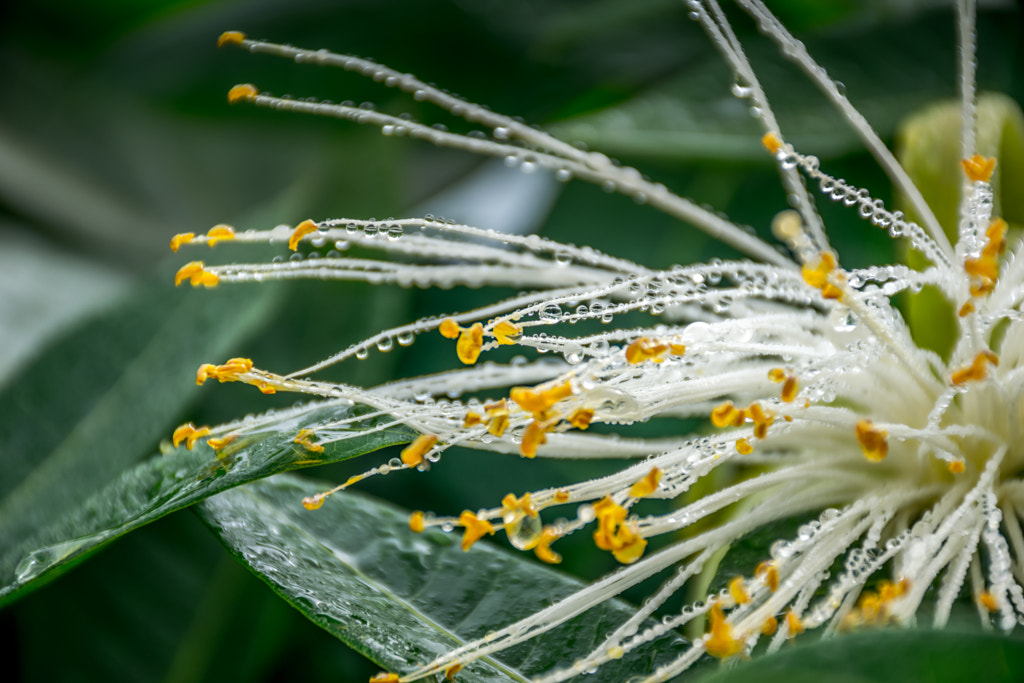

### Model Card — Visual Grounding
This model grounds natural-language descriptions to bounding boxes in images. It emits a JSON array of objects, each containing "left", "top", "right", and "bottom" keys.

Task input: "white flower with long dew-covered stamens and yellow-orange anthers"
[{"left": 171, "top": 0, "right": 1024, "bottom": 682}]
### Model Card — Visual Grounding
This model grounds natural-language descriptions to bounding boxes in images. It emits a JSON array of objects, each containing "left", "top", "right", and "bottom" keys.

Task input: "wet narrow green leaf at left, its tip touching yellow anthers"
[{"left": 0, "top": 400, "right": 414, "bottom": 602}]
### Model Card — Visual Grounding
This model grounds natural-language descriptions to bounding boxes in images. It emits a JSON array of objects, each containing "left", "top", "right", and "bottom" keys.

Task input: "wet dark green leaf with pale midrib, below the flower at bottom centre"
[{"left": 199, "top": 475, "right": 686, "bottom": 681}]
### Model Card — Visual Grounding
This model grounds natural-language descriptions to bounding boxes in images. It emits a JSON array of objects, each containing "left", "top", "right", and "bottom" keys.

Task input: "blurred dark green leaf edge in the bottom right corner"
[{"left": 700, "top": 630, "right": 1024, "bottom": 683}]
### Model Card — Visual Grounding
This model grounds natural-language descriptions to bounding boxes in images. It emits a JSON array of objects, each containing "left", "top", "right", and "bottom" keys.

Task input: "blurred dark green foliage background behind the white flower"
[{"left": 0, "top": 0, "right": 1024, "bottom": 682}]
